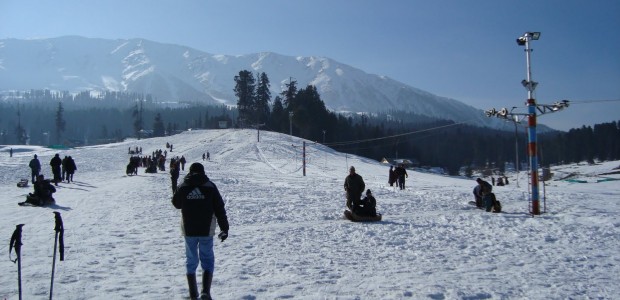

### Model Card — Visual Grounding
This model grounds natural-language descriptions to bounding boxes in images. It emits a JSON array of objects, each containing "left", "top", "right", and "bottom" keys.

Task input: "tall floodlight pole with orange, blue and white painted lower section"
[{"left": 525, "top": 33, "right": 540, "bottom": 215}]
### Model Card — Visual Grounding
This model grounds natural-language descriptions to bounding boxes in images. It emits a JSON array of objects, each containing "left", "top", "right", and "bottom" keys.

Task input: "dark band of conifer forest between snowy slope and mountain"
[{"left": 0, "top": 77, "right": 620, "bottom": 174}]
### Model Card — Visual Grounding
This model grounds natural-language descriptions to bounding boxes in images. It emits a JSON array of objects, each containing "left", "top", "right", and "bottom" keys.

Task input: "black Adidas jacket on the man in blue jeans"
[{"left": 172, "top": 173, "right": 228, "bottom": 236}]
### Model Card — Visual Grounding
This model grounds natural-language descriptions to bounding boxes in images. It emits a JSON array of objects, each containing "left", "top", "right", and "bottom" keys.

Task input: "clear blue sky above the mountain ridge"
[{"left": 0, "top": 0, "right": 620, "bottom": 130}]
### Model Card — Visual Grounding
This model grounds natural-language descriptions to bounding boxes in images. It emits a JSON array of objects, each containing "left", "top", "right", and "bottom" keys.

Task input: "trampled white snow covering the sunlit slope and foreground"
[{"left": 0, "top": 129, "right": 620, "bottom": 299}]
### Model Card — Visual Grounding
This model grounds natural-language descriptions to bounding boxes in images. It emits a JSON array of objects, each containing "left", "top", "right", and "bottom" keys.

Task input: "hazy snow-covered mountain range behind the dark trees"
[{"left": 0, "top": 36, "right": 505, "bottom": 128}]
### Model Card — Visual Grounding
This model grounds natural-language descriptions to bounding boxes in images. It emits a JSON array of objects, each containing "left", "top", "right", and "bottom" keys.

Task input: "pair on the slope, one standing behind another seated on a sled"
[{"left": 344, "top": 166, "right": 377, "bottom": 217}]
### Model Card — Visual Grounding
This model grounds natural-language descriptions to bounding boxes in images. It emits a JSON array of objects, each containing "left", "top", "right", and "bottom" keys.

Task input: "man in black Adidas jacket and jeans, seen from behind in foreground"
[{"left": 172, "top": 163, "right": 229, "bottom": 299}]
